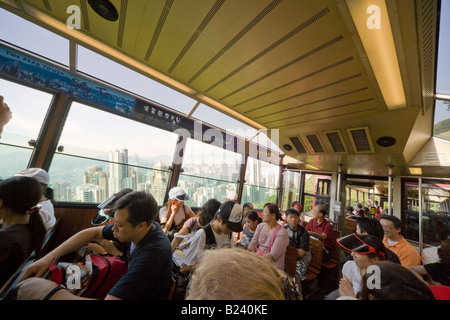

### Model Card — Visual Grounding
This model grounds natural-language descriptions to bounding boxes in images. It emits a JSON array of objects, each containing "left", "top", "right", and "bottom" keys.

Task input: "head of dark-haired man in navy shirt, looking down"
[{"left": 112, "top": 191, "right": 158, "bottom": 243}]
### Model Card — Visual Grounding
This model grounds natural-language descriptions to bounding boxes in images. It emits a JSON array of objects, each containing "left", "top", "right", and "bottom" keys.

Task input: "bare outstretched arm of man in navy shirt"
[{"left": 19, "top": 226, "right": 104, "bottom": 282}]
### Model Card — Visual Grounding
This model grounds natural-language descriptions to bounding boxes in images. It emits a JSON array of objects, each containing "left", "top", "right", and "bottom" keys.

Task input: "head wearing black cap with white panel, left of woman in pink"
[{"left": 214, "top": 201, "right": 242, "bottom": 234}]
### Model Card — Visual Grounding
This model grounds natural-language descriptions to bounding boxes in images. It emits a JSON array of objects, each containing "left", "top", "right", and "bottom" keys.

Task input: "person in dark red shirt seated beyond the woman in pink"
[{"left": 306, "top": 205, "right": 334, "bottom": 261}]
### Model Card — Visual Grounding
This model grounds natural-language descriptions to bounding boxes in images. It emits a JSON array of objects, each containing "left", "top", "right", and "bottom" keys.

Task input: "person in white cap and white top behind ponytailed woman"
[{"left": 15, "top": 168, "right": 56, "bottom": 230}]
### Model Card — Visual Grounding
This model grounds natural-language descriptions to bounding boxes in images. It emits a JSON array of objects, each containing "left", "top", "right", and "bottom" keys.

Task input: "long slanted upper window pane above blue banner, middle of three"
[{"left": 77, "top": 46, "right": 195, "bottom": 114}]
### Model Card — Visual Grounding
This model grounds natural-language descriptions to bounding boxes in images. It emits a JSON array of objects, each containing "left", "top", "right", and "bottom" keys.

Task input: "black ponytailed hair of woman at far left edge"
[{"left": 0, "top": 176, "right": 46, "bottom": 254}]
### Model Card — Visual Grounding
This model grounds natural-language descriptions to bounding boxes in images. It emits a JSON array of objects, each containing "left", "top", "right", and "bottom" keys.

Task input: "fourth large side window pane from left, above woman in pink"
[{"left": 241, "top": 157, "right": 280, "bottom": 209}]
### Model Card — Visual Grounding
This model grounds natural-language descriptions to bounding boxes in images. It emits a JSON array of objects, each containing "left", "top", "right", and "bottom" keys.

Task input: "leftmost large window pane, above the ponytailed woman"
[{"left": 0, "top": 79, "right": 53, "bottom": 178}]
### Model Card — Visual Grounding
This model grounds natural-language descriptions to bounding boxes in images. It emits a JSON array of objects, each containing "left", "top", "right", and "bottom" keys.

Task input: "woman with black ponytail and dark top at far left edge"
[{"left": 0, "top": 177, "right": 46, "bottom": 288}]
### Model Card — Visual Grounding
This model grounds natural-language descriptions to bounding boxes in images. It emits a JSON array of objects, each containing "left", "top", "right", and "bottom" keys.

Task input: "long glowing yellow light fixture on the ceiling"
[{"left": 345, "top": 0, "right": 406, "bottom": 110}]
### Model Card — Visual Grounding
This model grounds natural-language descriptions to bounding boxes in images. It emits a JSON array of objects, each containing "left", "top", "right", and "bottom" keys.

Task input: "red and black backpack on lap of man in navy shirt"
[{"left": 47, "top": 254, "right": 127, "bottom": 300}]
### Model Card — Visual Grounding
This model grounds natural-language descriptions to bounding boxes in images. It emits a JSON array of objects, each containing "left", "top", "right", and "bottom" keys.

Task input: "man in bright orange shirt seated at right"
[{"left": 380, "top": 215, "right": 421, "bottom": 268}]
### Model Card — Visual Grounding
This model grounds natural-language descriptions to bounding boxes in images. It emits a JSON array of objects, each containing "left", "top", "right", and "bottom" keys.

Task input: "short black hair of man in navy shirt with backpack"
[{"left": 112, "top": 191, "right": 158, "bottom": 226}]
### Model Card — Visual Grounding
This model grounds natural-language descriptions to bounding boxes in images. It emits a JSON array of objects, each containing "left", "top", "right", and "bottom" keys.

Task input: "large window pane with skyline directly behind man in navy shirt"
[{"left": 49, "top": 103, "right": 178, "bottom": 205}]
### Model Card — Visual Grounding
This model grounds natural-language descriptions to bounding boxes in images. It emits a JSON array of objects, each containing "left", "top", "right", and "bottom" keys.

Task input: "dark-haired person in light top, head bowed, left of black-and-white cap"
[{"left": 171, "top": 198, "right": 221, "bottom": 252}]
